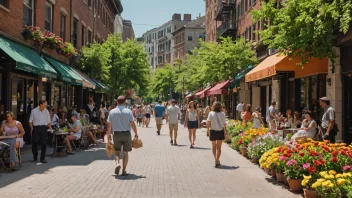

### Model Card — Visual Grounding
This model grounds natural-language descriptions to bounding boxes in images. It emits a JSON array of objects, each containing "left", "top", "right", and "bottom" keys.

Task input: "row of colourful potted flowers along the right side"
[{"left": 228, "top": 121, "right": 352, "bottom": 198}]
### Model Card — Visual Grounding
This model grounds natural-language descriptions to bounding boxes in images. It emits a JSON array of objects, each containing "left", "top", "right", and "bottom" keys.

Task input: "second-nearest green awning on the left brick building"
[{"left": 45, "top": 56, "right": 83, "bottom": 86}]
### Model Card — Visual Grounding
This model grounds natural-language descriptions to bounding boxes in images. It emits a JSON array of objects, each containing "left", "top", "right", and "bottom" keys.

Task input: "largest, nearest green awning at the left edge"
[{"left": 0, "top": 36, "right": 57, "bottom": 78}]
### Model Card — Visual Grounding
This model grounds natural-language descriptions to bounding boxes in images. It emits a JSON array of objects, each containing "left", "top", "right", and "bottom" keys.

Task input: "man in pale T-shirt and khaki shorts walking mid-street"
[{"left": 166, "top": 99, "right": 180, "bottom": 145}]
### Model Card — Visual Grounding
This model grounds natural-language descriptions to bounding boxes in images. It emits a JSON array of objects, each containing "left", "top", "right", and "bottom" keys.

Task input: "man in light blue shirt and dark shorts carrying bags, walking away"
[{"left": 107, "top": 96, "right": 138, "bottom": 176}]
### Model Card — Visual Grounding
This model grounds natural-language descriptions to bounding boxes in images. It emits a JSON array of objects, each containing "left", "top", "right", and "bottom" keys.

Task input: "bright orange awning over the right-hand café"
[{"left": 245, "top": 54, "right": 328, "bottom": 82}]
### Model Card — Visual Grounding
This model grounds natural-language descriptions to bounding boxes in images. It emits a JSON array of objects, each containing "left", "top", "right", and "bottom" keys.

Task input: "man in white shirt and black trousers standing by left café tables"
[{"left": 29, "top": 100, "right": 52, "bottom": 163}]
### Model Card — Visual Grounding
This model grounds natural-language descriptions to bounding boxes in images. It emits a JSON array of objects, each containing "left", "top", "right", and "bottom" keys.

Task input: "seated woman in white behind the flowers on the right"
[{"left": 291, "top": 111, "right": 317, "bottom": 140}]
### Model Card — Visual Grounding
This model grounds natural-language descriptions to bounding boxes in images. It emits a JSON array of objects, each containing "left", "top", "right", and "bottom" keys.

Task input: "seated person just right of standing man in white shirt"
[{"left": 65, "top": 114, "right": 82, "bottom": 155}]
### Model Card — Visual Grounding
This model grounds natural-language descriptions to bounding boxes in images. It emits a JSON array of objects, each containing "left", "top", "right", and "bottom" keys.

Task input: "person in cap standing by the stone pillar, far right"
[{"left": 319, "top": 97, "right": 337, "bottom": 143}]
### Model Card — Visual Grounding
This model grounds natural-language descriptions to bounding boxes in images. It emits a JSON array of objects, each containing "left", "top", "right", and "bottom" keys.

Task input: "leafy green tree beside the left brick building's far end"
[{"left": 82, "top": 34, "right": 150, "bottom": 95}]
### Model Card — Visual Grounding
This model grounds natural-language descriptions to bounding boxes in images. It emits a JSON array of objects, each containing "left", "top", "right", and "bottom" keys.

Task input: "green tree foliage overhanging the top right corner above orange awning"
[{"left": 252, "top": 0, "right": 352, "bottom": 65}]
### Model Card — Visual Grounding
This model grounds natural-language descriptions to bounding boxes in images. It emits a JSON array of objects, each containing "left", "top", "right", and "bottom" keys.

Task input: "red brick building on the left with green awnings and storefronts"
[{"left": 0, "top": 0, "right": 123, "bottom": 144}]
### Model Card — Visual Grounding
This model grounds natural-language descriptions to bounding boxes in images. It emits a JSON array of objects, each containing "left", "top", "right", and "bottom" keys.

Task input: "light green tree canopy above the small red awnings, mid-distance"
[{"left": 151, "top": 37, "right": 258, "bottom": 98}]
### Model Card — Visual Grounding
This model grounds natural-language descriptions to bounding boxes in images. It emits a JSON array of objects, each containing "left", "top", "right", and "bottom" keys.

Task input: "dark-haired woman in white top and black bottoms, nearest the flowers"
[{"left": 207, "top": 102, "right": 226, "bottom": 168}]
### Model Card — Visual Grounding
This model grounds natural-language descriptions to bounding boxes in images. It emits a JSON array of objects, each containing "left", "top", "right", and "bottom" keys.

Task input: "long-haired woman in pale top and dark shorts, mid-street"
[{"left": 185, "top": 101, "right": 200, "bottom": 148}]
